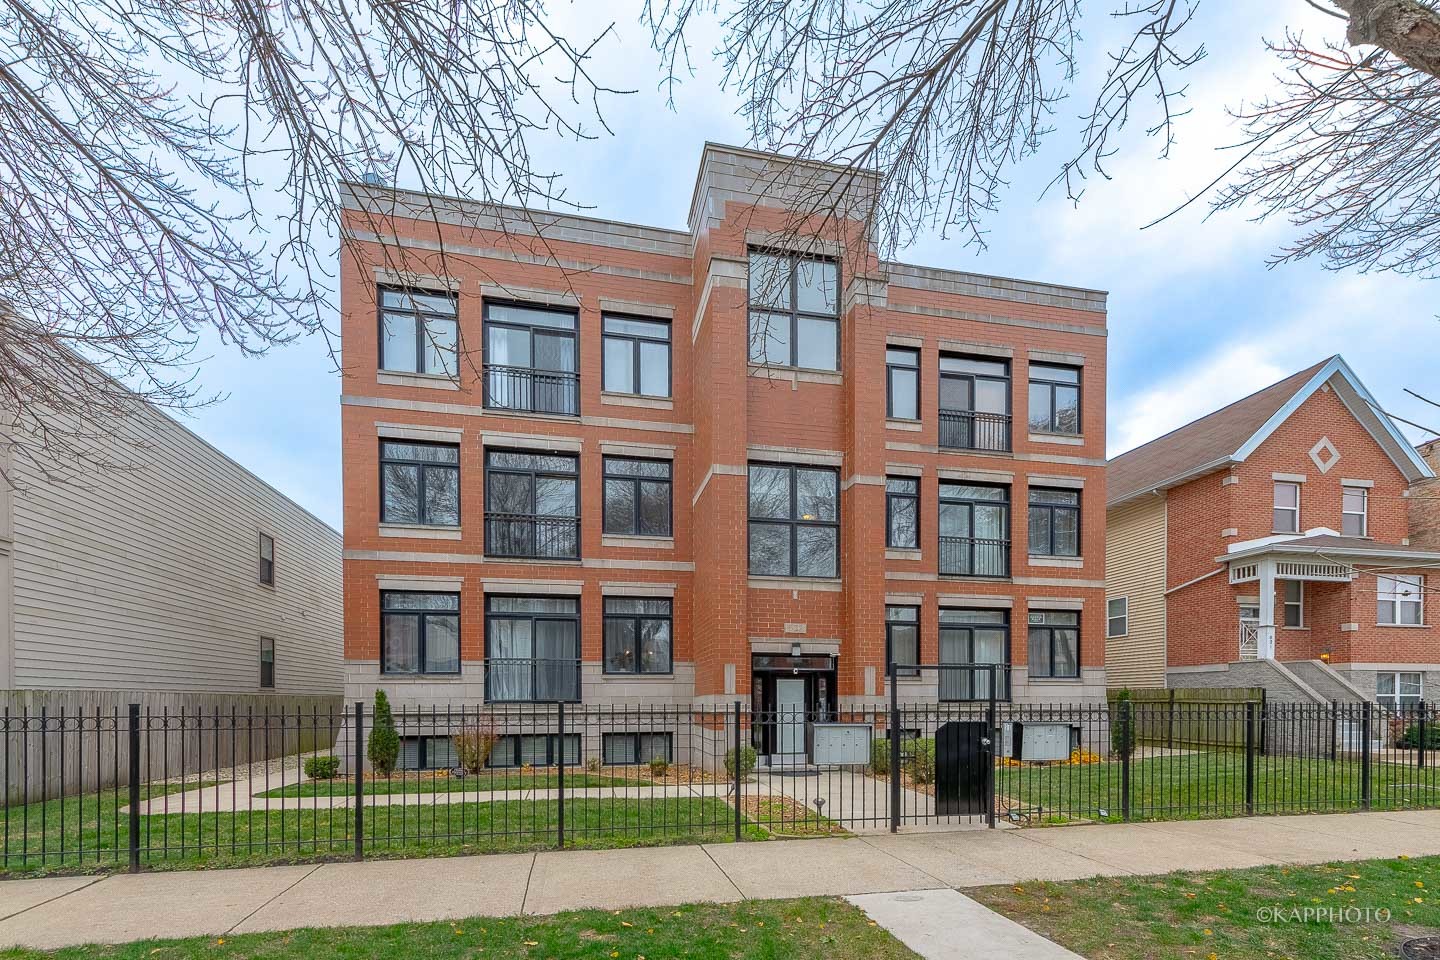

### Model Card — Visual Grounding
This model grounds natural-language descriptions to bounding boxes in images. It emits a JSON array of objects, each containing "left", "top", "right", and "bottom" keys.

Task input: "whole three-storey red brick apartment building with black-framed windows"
[{"left": 341, "top": 145, "right": 1106, "bottom": 753}]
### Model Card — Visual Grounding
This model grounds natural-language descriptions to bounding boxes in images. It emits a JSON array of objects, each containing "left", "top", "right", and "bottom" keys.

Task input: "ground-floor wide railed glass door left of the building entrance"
[{"left": 485, "top": 596, "right": 580, "bottom": 702}]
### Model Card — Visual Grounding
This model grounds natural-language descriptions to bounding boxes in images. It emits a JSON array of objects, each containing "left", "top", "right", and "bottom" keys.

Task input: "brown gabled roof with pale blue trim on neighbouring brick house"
[{"left": 1106, "top": 354, "right": 1434, "bottom": 507}]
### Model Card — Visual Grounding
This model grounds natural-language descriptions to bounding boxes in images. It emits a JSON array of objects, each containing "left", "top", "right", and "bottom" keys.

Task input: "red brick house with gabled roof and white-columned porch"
[{"left": 1106, "top": 356, "right": 1440, "bottom": 704}]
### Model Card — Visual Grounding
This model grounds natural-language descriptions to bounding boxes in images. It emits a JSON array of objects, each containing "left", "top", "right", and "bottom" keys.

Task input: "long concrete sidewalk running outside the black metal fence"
[{"left": 0, "top": 810, "right": 1440, "bottom": 960}]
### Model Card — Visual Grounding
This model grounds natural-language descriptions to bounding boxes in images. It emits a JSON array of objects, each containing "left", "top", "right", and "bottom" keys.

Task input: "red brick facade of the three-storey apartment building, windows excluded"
[{"left": 341, "top": 147, "right": 1106, "bottom": 713}]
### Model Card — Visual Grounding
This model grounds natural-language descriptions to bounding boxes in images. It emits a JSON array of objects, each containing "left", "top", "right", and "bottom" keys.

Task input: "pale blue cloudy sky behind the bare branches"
[{"left": 174, "top": 0, "right": 1440, "bottom": 528}]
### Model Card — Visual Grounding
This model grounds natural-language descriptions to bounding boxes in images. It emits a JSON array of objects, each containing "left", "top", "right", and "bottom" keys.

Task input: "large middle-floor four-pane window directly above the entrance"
[{"left": 750, "top": 463, "right": 840, "bottom": 577}]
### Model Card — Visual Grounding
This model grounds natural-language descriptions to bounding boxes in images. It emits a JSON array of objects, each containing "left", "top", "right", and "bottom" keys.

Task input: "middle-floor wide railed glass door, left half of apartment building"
[{"left": 485, "top": 449, "right": 580, "bottom": 560}]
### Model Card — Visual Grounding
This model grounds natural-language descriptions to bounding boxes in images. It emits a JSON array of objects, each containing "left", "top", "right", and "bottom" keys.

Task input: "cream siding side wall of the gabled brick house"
[{"left": 1104, "top": 497, "right": 1165, "bottom": 688}]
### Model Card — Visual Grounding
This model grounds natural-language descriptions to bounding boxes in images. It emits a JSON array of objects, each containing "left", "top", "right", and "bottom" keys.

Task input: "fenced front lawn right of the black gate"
[{"left": 995, "top": 751, "right": 1440, "bottom": 822}]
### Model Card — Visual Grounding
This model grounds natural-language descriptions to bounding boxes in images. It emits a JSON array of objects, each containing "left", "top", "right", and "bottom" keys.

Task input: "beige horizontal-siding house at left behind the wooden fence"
[{"left": 0, "top": 404, "right": 343, "bottom": 705}]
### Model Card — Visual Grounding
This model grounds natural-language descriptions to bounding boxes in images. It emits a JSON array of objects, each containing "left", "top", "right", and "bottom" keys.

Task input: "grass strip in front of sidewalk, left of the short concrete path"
[{"left": 0, "top": 898, "right": 916, "bottom": 960}]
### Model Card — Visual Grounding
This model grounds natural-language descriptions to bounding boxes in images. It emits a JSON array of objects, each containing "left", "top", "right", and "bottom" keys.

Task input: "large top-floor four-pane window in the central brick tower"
[{"left": 750, "top": 250, "right": 840, "bottom": 370}]
